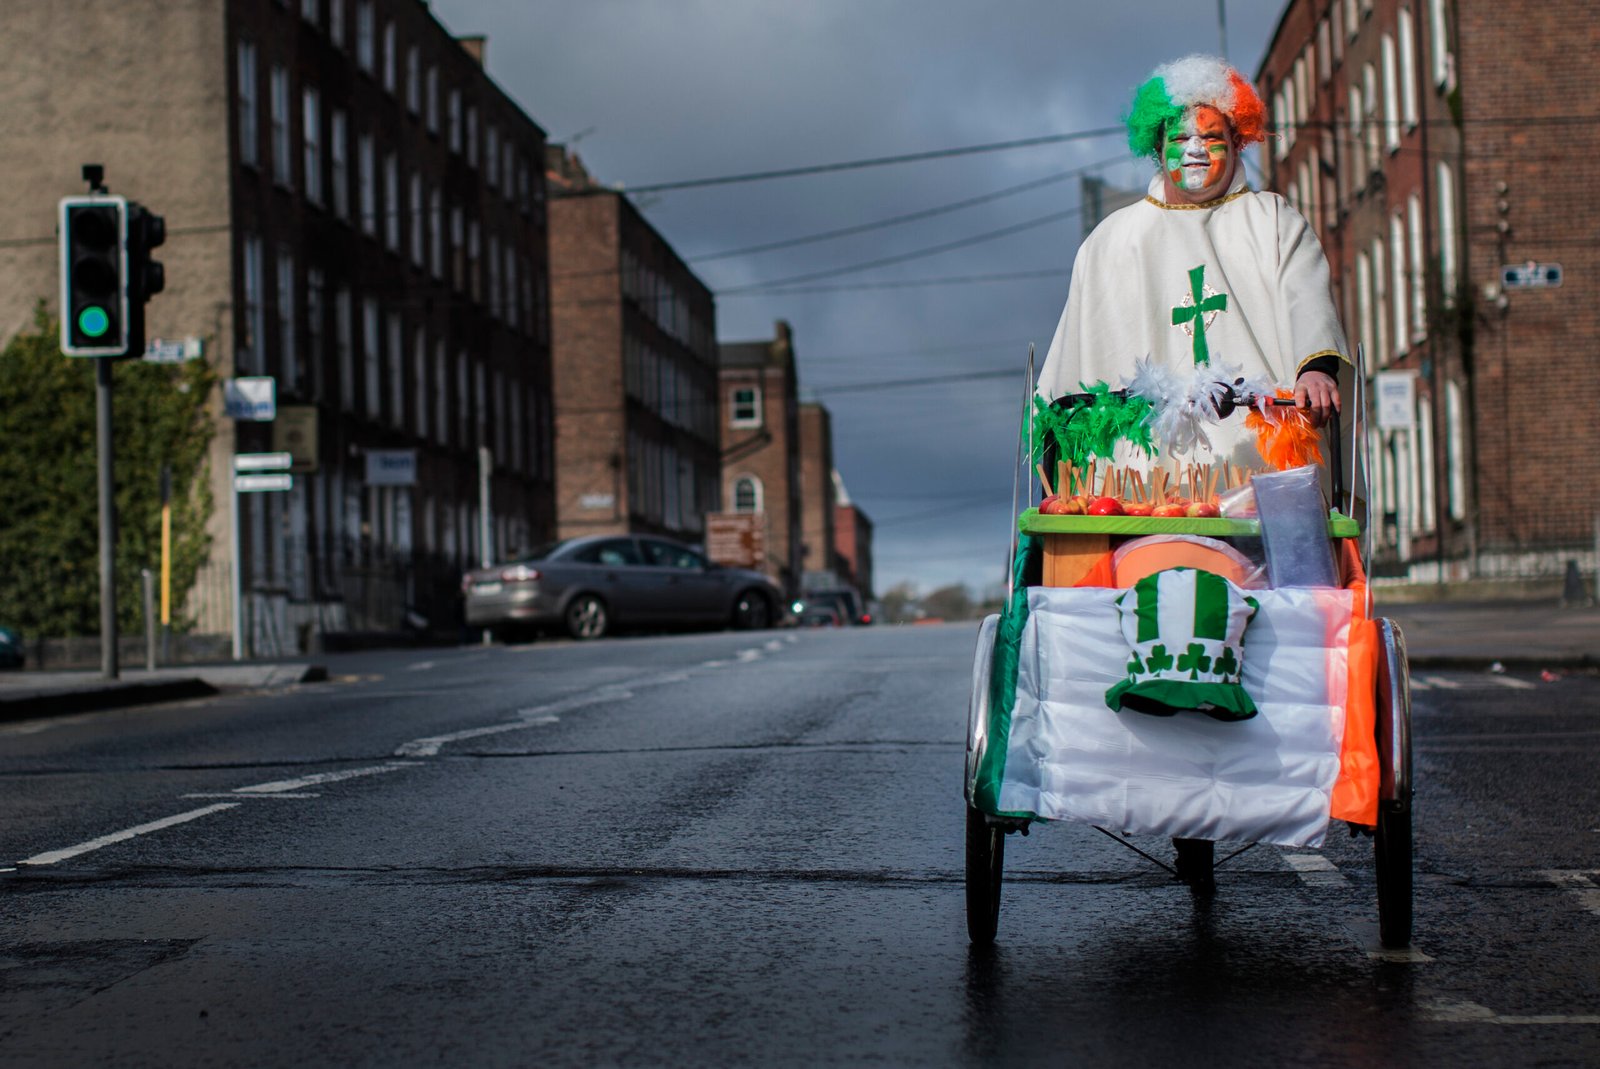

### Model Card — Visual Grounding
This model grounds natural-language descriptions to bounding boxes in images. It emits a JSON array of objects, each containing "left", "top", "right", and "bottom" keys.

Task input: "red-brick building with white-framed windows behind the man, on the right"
[{"left": 1259, "top": 0, "right": 1600, "bottom": 578}]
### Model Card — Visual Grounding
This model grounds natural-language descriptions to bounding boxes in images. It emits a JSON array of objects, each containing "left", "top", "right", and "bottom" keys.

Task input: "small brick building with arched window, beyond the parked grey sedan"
[{"left": 717, "top": 320, "right": 803, "bottom": 597}]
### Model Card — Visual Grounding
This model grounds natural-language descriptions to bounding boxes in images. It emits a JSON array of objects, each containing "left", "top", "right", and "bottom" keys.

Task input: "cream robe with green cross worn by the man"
[{"left": 1038, "top": 174, "right": 1352, "bottom": 467}]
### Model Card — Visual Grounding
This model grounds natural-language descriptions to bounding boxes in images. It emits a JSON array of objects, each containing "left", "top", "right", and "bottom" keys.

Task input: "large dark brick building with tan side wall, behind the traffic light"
[{"left": 0, "top": 0, "right": 554, "bottom": 653}]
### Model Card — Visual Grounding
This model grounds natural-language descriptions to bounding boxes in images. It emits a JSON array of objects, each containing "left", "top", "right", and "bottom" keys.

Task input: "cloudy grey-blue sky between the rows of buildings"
[{"left": 432, "top": 0, "right": 1283, "bottom": 594}]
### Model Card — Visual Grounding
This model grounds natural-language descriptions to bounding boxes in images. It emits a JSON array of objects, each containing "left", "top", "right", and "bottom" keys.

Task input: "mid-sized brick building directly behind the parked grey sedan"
[{"left": 547, "top": 146, "right": 722, "bottom": 543}]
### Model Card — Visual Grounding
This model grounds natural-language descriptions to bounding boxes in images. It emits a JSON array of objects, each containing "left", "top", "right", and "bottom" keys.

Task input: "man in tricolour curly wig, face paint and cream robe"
[{"left": 1038, "top": 56, "right": 1350, "bottom": 485}]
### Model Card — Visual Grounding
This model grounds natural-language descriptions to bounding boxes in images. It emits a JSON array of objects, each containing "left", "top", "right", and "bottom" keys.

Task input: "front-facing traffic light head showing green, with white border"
[{"left": 59, "top": 194, "right": 128, "bottom": 357}]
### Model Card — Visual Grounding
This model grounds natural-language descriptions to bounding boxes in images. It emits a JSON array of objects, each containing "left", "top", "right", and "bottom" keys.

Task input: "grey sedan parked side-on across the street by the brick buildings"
[{"left": 461, "top": 535, "right": 782, "bottom": 639}]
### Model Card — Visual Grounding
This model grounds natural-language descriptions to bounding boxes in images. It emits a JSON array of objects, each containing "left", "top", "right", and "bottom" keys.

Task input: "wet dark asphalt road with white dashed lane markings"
[{"left": 0, "top": 626, "right": 1600, "bottom": 1066}]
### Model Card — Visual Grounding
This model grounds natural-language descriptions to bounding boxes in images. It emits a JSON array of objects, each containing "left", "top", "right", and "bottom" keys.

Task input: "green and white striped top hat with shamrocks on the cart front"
[{"left": 1106, "top": 568, "right": 1258, "bottom": 720}]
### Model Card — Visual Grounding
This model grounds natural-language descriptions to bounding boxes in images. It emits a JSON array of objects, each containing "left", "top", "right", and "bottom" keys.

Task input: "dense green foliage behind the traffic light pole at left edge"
[{"left": 0, "top": 301, "right": 216, "bottom": 635}]
